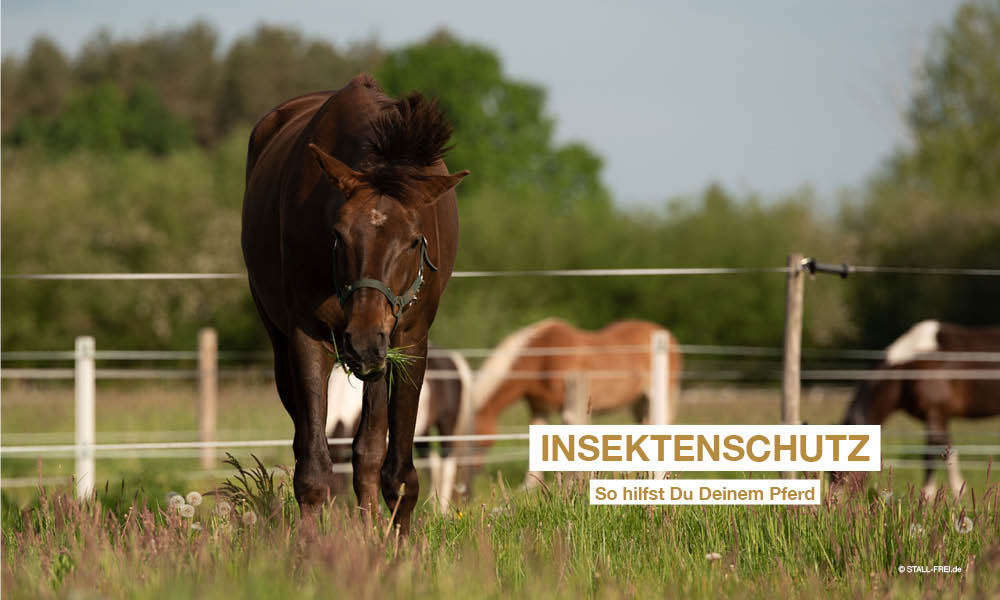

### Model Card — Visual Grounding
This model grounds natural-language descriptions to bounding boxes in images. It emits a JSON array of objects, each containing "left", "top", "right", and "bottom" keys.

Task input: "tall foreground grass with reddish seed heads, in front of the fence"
[{"left": 2, "top": 463, "right": 1000, "bottom": 598}]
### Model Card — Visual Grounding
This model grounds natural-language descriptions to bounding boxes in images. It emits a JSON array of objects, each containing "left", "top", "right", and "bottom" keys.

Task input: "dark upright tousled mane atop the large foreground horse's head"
[{"left": 361, "top": 92, "right": 453, "bottom": 198}]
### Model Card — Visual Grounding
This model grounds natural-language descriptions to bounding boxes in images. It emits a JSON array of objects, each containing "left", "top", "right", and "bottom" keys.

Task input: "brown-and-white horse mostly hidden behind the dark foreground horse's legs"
[{"left": 326, "top": 348, "right": 473, "bottom": 511}]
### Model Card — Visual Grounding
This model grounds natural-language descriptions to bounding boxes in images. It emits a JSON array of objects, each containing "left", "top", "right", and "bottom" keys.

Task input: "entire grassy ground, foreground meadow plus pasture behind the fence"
[{"left": 2, "top": 381, "right": 1000, "bottom": 598}]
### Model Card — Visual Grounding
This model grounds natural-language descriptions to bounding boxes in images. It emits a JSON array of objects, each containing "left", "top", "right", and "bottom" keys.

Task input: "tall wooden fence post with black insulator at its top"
[{"left": 781, "top": 253, "right": 805, "bottom": 479}]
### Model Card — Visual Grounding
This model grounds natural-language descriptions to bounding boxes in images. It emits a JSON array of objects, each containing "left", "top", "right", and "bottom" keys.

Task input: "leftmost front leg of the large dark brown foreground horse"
[{"left": 289, "top": 328, "right": 336, "bottom": 516}]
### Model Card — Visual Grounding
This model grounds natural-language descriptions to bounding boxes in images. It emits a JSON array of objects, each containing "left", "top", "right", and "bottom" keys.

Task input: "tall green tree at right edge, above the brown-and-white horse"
[{"left": 844, "top": 2, "right": 1000, "bottom": 346}]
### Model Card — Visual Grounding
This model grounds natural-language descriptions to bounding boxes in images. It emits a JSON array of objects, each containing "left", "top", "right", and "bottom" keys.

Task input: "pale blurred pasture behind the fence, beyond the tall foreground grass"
[{"left": 0, "top": 380, "right": 1000, "bottom": 502}]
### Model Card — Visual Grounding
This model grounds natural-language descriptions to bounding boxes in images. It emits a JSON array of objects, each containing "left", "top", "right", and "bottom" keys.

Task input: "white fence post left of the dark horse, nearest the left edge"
[{"left": 74, "top": 336, "right": 96, "bottom": 499}]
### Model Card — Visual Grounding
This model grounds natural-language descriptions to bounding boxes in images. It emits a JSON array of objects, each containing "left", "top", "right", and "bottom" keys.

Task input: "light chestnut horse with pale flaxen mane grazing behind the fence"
[{"left": 473, "top": 319, "right": 681, "bottom": 434}]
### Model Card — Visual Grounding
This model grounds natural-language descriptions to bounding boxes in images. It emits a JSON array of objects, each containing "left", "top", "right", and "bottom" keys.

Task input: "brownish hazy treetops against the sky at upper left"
[{"left": 3, "top": 22, "right": 381, "bottom": 147}]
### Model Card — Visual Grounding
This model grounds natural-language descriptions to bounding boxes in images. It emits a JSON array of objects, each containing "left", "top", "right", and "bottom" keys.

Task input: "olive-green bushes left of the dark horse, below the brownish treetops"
[{"left": 0, "top": 129, "right": 266, "bottom": 350}]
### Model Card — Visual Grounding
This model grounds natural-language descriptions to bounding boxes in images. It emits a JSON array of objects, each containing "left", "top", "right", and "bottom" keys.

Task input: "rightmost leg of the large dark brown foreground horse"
[{"left": 382, "top": 341, "right": 427, "bottom": 535}]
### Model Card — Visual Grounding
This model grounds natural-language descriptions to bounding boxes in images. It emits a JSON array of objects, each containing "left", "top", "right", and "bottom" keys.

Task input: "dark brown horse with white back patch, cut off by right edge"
[{"left": 834, "top": 321, "right": 1000, "bottom": 496}]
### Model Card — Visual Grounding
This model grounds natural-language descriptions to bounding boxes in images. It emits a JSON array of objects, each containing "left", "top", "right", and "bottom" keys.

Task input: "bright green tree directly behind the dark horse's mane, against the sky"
[{"left": 377, "top": 31, "right": 610, "bottom": 213}]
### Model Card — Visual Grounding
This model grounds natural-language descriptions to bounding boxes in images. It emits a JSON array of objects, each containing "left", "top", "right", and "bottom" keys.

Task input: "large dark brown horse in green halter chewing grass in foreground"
[{"left": 242, "top": 75, "right": 468, "bottom": 533}]
